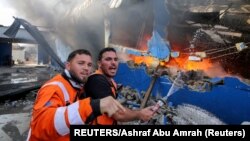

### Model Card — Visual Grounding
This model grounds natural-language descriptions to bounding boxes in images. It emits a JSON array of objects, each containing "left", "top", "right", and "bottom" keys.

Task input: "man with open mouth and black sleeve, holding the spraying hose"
[{"left": 85, "top": 48, "right": 154, "bottom": 125}]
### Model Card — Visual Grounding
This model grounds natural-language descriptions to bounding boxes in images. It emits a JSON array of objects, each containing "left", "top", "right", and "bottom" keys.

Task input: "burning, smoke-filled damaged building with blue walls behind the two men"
[{"left": 0, "top": 0, "right": 250, "bottom": 139}]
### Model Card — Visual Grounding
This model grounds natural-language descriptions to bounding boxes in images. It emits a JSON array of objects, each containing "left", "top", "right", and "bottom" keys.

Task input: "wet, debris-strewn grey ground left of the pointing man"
[{"left": 0, "top": 66, "right": 56, "bottom": 141}]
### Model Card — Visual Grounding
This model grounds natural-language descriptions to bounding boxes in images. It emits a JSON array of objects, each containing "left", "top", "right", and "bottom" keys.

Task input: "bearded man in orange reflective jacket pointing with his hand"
[{"left": 27, "top": 49, "right": 125, "bottom": 141}]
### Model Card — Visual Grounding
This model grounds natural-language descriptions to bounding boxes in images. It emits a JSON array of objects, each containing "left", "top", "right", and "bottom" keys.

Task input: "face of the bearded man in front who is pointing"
[{"left": 66, "top": 54, "right": 92, "bottom": 83}]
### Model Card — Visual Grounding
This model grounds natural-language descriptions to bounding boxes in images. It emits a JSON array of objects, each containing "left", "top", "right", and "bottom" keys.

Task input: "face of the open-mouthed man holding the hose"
[{"left": 98, "top": 51, "right": 118, "bottom": 78}]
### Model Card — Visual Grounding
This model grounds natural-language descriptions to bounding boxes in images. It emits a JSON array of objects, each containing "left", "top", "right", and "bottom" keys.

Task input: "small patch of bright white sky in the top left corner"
[{"left": 0, "top": 0, "right": 17, "bottom": 26}]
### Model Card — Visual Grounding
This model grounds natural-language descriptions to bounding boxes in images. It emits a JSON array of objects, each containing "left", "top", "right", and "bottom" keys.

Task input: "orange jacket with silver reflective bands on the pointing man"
[{"left": 27, "top": 75, "right": 97, "bottom": 141}]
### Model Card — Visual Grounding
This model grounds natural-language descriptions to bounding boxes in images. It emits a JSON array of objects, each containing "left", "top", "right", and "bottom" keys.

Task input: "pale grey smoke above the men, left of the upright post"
[{"left": 5, "top": 0, "right": 104, "bottom": 59}]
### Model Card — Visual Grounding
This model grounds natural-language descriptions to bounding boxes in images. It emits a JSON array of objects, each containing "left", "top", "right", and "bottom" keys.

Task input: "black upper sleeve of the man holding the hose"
[{"left": 84, "top": 74, "right": 113, "bottom": 99}]
